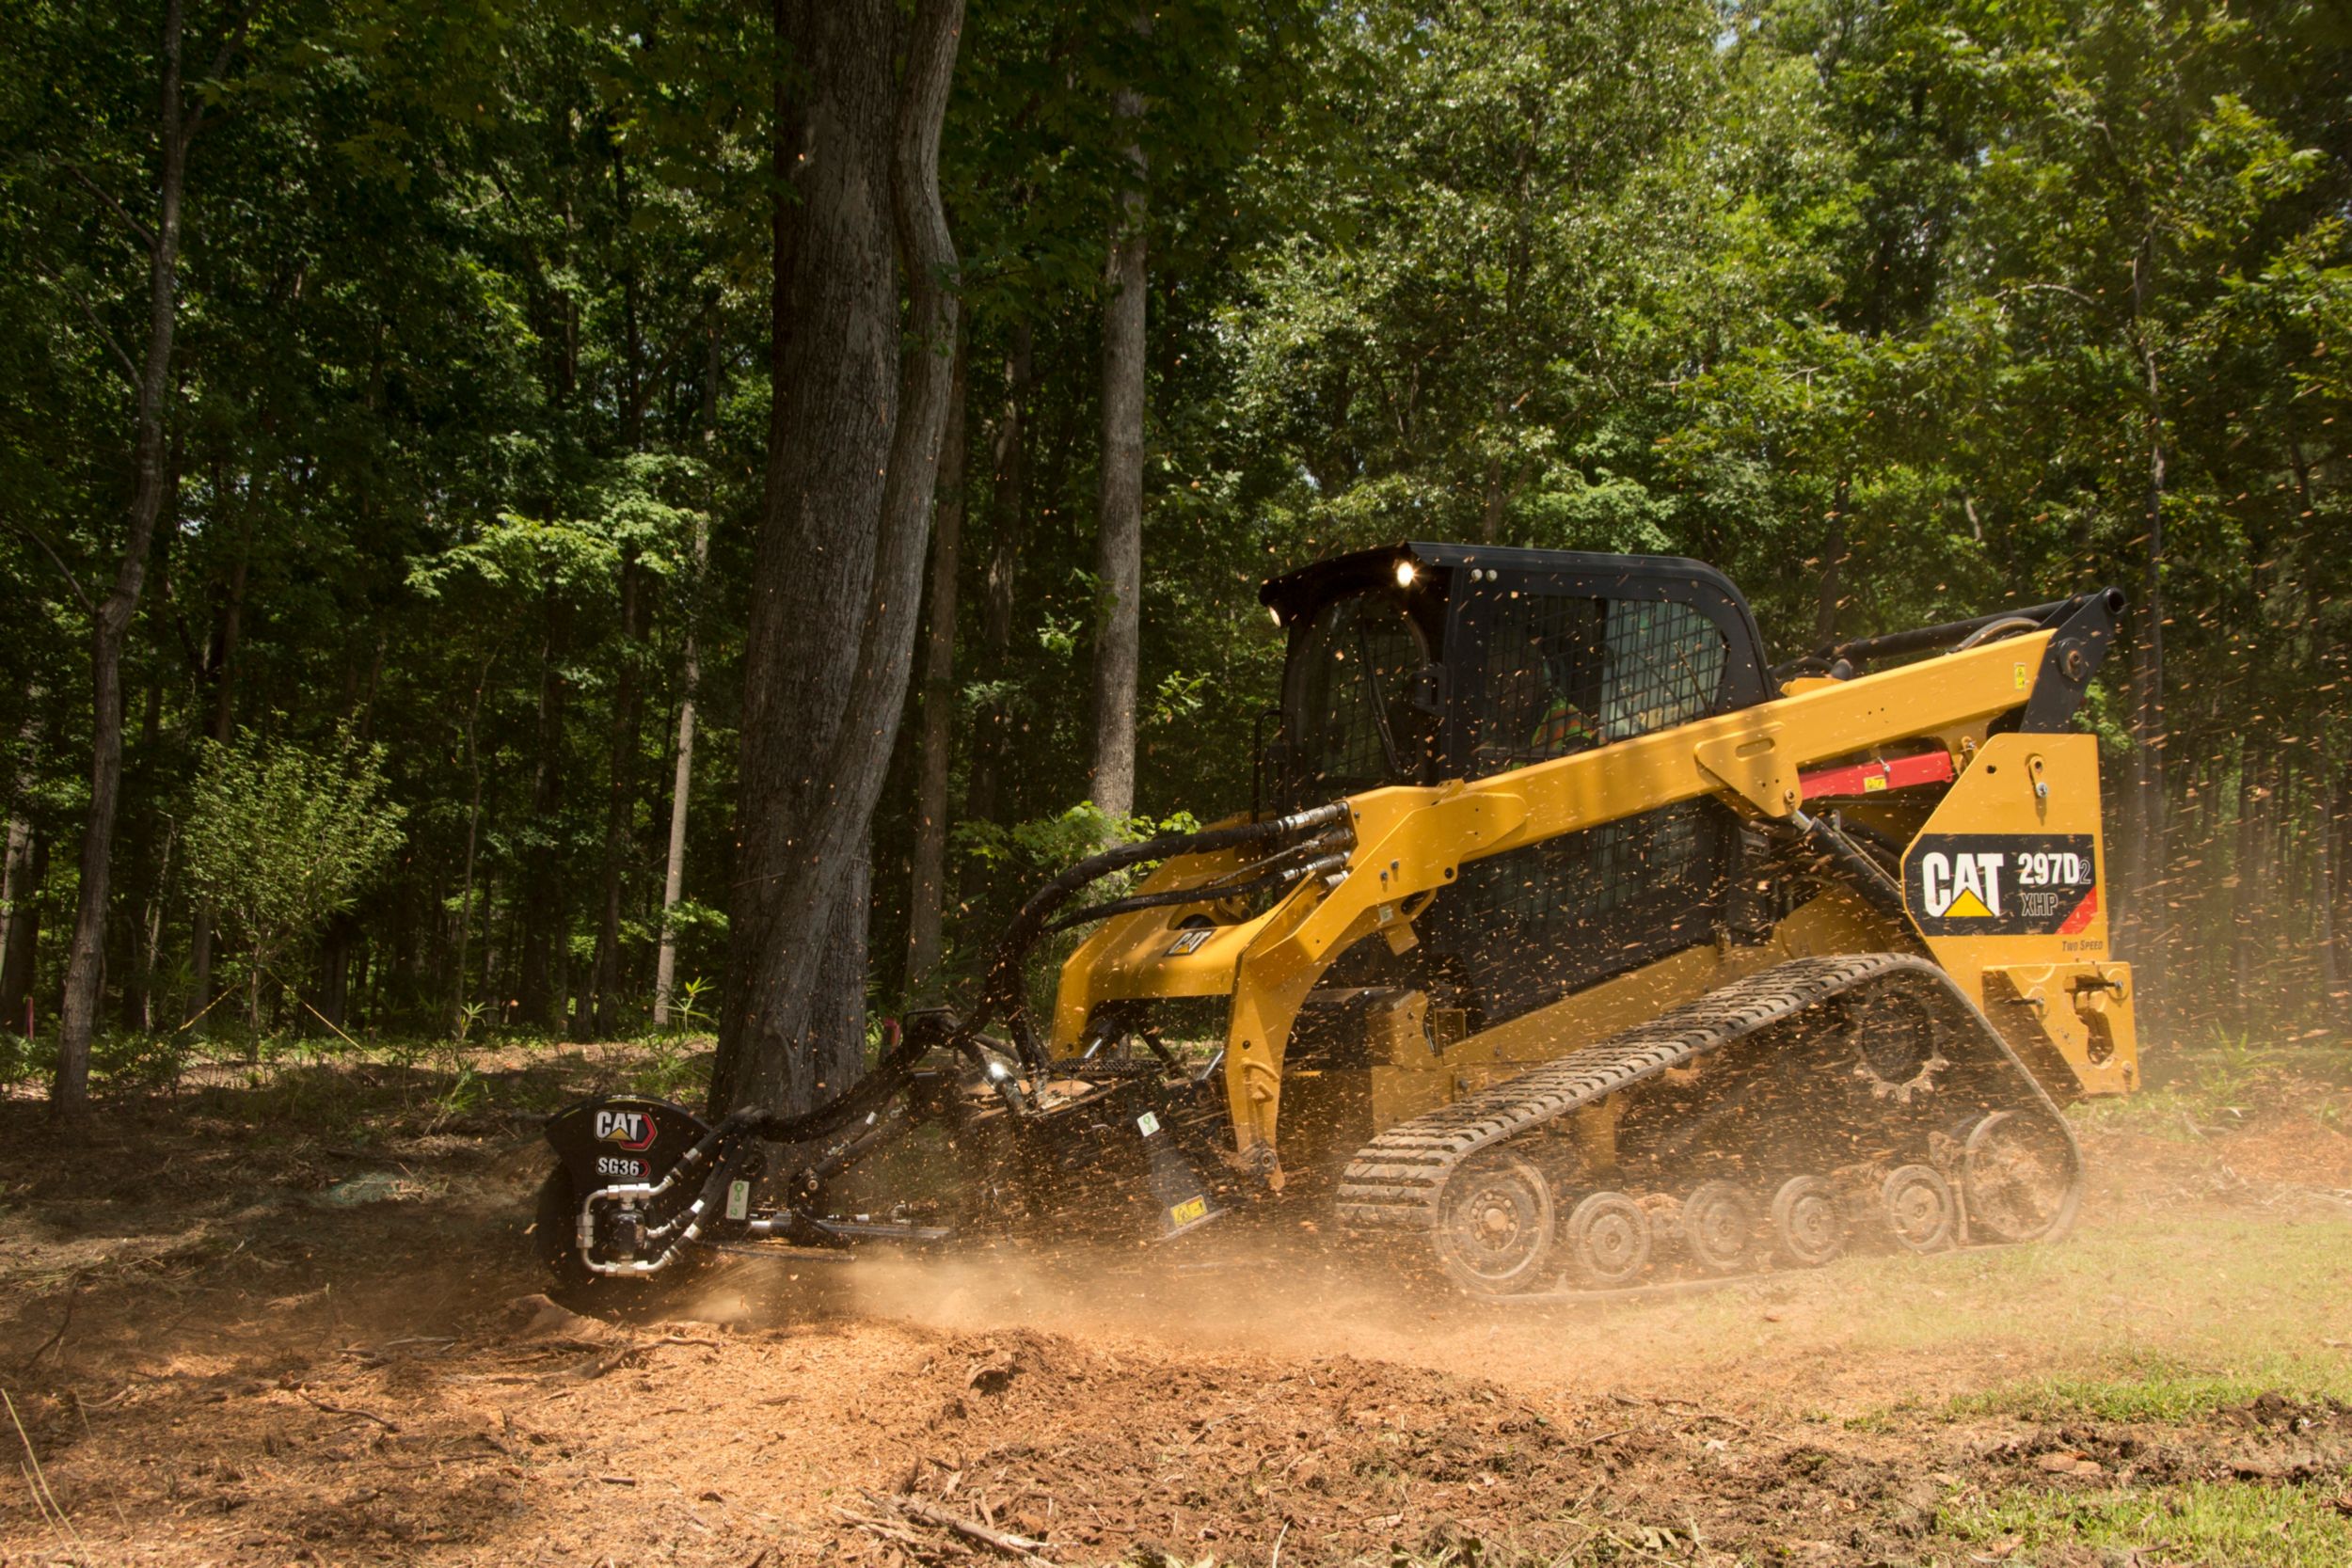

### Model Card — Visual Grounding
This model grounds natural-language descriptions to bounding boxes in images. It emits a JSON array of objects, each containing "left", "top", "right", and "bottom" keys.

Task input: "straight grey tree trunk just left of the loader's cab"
[{"left": 1094, "top": 87, "right": 1148, "bottom": 818}]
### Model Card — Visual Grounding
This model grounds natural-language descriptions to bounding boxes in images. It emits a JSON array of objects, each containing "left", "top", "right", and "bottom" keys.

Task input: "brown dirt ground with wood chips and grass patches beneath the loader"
[{"left": 0, "top": 1058, "right": 2352, "bottom": 1568}]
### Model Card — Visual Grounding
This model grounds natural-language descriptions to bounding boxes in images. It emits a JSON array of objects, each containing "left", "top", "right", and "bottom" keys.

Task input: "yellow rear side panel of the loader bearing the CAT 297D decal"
[{"left": 1903, "top": 734, "right": 2138, "bottom": 1096}]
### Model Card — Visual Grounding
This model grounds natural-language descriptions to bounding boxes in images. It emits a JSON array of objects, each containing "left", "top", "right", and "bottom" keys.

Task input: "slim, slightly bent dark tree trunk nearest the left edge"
[{"left": 50, "top": 0, "right": 193, "bottom": 1117}]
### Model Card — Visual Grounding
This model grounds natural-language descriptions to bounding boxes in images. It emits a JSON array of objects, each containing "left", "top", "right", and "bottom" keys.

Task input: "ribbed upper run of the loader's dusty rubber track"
[{"left": 1336, "top": 952, "right": 1929, "bottom": 1234}]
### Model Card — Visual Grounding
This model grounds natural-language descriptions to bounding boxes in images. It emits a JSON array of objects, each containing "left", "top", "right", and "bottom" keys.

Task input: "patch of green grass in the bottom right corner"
[{"left": 1936, "top": 1481, "right": 2352, "bottom": 1568}]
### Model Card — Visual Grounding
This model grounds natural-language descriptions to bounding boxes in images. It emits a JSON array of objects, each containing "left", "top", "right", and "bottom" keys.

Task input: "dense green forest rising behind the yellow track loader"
[{"left": 0, "top": 0, "right": 2352, "bottom": 1105}]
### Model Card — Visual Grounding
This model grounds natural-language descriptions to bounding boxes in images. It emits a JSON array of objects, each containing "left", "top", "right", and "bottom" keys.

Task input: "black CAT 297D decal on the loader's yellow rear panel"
[{"left": 1903, "top": 832, "right": 2098, "bottom": 936}]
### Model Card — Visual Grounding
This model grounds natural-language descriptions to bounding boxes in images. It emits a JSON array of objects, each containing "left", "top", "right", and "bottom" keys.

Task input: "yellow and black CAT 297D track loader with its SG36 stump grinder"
[{"left": 539, "top": 543, "right": 2138, "bottom": 1295}]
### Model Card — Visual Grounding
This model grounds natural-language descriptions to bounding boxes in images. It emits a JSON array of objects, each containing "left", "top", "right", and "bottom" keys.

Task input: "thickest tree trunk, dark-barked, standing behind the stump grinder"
[{"left": 710, "top": 0, "right": 964, "bottom": 1112}]
